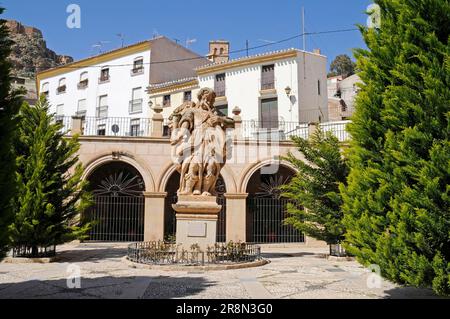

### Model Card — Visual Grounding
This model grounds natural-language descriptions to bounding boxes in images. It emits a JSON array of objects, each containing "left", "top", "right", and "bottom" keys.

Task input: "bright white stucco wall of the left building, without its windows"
[{"left": 40, "top": 50, "right": 151, "bottom": 118}]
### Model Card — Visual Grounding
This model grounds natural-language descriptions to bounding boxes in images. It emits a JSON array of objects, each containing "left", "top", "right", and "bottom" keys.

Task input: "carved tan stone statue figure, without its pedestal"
[{"left": 169, "top": 88, "right": 234, "bottom": 196}]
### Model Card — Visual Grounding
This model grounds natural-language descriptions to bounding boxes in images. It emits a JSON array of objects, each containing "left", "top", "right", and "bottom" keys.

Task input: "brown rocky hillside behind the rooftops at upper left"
[{"left": 7, "top": 20, "right": 73, "bottom": 78}]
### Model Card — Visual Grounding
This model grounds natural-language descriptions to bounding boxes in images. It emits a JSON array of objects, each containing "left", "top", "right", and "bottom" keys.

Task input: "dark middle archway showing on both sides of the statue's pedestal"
[{"left": 164, "top": 171, "right": 227, "bottom": 243}]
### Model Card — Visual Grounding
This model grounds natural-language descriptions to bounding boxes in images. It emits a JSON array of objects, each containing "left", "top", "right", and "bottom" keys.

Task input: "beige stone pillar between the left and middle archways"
[{"left": 144, "top": 193, "right": 167, "bottom": 241}]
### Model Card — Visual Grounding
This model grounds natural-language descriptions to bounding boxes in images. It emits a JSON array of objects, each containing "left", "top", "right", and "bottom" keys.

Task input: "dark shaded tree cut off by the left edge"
[{"left": 0, "top": 7, "right": 22, "bottom": 258}]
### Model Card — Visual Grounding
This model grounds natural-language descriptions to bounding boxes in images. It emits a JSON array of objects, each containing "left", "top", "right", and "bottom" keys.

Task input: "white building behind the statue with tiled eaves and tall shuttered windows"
[{"left": 148, "top": 47, "right": 329, "bottom": 140}]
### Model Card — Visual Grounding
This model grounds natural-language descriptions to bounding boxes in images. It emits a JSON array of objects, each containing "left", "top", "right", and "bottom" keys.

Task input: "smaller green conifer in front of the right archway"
[{"left": 281, "top": 129, "right": 349, "bottom": 245}]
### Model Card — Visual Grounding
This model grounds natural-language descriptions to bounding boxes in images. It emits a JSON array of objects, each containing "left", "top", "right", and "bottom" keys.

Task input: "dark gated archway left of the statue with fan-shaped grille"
[{"left": 85, "top": 162, "right": 145, "bottom": 242}]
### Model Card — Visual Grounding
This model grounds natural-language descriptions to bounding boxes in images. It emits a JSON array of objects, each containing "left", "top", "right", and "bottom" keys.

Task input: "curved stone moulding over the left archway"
[{"left": 82, "top": 154, "right": 156, "bottom": 193}]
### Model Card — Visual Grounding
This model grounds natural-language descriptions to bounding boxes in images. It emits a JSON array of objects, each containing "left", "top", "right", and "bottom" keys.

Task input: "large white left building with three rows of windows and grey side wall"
[{"left": 37, "top": 37, "right": 208, "bottom": 136}]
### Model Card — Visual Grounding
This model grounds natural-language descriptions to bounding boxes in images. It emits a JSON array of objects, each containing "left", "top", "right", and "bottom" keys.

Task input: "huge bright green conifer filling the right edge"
[{"left": 342, "top": 0, "right": 450, "bottom": 295}]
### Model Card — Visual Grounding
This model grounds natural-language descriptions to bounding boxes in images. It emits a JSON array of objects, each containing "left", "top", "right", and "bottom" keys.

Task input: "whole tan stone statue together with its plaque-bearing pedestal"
[{"left": 169, "top": 88, "right": 234, "bottom": 248}]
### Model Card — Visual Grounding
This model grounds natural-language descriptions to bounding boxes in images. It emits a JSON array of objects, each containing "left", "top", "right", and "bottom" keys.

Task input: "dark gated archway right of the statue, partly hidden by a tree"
[{"left": 246, "top": 165, "right": 305, "bottom": 244}]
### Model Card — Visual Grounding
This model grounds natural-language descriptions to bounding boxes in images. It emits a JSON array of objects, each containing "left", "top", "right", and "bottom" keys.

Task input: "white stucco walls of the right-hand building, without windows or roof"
[{"left": 199, "top": 52, "right": 328, "bottom": 122}]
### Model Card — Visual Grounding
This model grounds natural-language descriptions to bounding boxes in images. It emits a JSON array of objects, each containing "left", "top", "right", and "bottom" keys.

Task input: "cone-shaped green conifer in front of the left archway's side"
[{"left": 10, "top": 97, "right": 90, "bottom": 257}]
